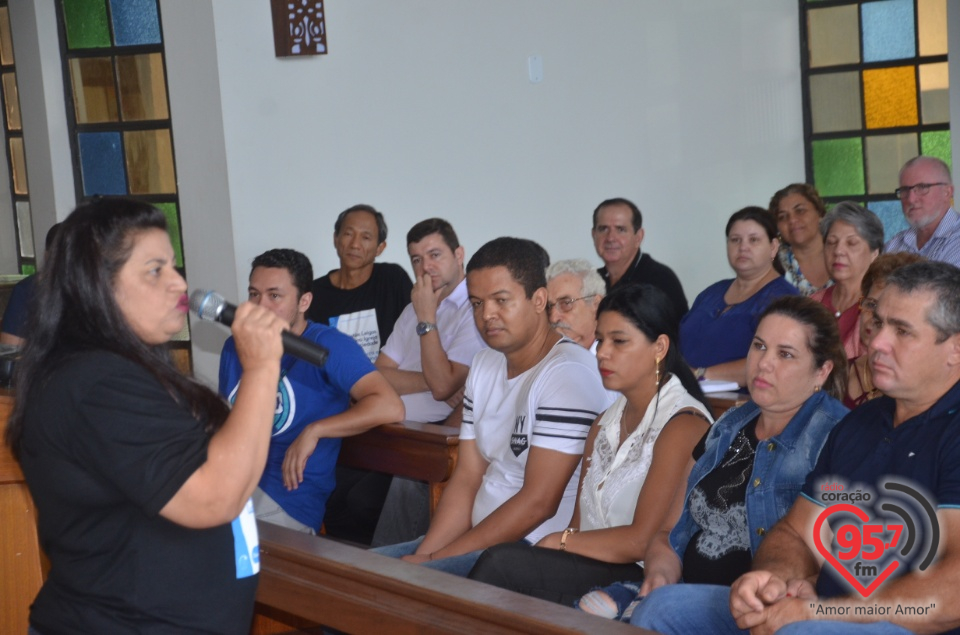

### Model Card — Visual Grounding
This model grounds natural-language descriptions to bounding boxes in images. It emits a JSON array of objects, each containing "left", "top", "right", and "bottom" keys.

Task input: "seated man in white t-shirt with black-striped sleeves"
[{"left": 376, "top": 238, "right": 609, "bottom": 575}]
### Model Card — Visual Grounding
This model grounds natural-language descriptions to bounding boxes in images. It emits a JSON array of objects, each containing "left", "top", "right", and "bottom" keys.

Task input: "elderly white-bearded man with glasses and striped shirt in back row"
[{"left": 884, "top": 156, "right": 960, "bottom": 267}]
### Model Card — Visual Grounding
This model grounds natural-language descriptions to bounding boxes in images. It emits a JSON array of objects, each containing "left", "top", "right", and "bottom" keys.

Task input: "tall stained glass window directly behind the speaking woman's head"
[{"left": 56, "top": 0, "right": 190, "bottom": 362}]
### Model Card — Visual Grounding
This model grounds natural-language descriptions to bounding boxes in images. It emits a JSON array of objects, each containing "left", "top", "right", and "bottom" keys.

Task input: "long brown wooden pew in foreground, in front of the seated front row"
[{"left": 253, "top": 523, "right": 650, "bottom": 635}]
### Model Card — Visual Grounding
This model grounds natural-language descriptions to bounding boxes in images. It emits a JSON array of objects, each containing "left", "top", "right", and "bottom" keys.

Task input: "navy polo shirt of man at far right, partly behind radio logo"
[{"left": 802, "top": 382, "right": 960, "bottom": 608}]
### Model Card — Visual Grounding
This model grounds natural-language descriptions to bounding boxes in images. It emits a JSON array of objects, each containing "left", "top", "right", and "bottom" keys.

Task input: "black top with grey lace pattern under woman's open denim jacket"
[{"left": 683, "top": 419, "right": 757, "bottom": 586}]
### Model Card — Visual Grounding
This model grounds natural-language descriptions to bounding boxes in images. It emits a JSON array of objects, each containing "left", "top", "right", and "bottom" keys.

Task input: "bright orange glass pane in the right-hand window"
[{"left": 863, "top": 66, "right": 918, "bottom": 128}]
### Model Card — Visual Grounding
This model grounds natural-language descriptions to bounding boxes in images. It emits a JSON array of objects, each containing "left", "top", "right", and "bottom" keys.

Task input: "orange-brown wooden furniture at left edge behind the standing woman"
[{"left": 0, "top": 390, "right": 47, "bottom": 633}]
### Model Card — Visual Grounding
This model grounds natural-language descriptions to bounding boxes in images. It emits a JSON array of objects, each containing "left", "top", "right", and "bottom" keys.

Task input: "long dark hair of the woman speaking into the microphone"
[{"left": 6, "top": 198, "right": 229, "bottom": 456}]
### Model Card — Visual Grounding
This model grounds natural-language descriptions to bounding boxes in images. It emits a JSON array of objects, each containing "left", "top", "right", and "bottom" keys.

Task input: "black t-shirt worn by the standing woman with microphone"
[{"left": 21, "top": 352, "right": 257, "bottom": 635}]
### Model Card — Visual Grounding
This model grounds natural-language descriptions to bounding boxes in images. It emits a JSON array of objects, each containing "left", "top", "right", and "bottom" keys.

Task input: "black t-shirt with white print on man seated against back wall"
[{"left": 307, "top": 262, "right": 413, "bottom": 361}]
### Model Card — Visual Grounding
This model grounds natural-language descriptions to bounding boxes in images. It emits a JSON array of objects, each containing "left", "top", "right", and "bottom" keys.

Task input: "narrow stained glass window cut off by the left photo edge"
[{"left": 0, "top": 0, "right": 36, "bottom": 274}]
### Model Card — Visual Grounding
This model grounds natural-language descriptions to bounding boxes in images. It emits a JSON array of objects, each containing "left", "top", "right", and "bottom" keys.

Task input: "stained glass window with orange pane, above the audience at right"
[{"left": 800, "top": 0, "right": 952, "bottom": 238}]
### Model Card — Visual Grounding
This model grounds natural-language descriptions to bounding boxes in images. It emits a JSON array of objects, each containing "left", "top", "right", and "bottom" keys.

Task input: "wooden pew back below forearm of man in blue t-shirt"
[{"left": 338, "top": 421, "right": 460, "bottom": 514}]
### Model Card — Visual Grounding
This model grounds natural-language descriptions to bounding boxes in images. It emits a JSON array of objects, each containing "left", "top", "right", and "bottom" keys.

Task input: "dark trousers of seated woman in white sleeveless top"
[{"left": 467, "top": 542, "right": 643, "bottom": 606}]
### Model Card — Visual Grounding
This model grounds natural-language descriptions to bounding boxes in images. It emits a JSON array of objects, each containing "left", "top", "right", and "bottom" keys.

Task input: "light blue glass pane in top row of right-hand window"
[{"left": 860, "top": 0, "right": 916, "bottom": 62}]
